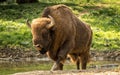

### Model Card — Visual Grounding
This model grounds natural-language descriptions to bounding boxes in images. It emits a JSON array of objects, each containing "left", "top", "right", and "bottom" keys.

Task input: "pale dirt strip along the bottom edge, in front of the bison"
[{"left": 12, "top": 70, "right": 120, "bottom": 75}]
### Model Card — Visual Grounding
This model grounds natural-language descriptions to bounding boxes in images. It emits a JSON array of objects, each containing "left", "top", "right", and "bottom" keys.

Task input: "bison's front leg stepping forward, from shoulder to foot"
[{"left": 51, "top": 41, "right": 73, "bottom": 70}]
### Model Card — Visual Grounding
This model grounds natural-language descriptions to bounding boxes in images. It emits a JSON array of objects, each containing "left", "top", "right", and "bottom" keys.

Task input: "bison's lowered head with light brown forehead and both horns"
[{"left": 27, "top": 16, "right": 54, "bottom": 54}]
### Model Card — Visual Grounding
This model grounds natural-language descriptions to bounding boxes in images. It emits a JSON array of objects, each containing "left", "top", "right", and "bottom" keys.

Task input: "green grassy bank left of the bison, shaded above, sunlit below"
[{"left": 0, "top": 3, "right": 46, "bottom": 48}]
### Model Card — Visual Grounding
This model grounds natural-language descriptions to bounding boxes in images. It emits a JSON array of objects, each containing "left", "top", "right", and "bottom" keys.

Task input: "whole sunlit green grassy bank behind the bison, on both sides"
[{"left": 0, "top": 0, "right": 120, "bottom": 50}]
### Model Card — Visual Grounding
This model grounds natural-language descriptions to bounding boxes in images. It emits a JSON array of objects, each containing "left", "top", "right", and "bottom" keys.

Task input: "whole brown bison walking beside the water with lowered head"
[{"left": 27, "top": 4, "right": 92, "bottom": 70}]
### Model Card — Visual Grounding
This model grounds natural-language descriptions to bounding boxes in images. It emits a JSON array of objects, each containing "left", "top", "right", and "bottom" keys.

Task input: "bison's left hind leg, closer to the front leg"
[{"left": 68, "top": 54, "right": 80, "bottom": 70}]
